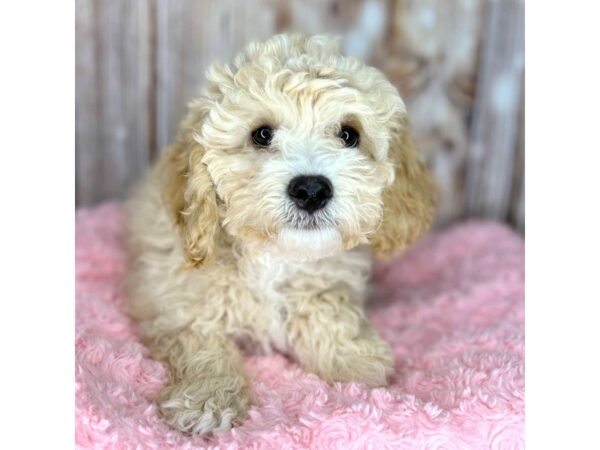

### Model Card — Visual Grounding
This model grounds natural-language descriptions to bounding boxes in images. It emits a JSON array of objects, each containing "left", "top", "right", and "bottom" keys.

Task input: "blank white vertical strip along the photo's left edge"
[{"left": 0, "top": 1, "right": 75, "bottom": 449}]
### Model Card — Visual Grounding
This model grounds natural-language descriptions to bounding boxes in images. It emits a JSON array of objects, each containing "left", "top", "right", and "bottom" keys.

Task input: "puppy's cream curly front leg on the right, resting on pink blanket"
[{"left": 287, "top": 288, "right": 394, "bottom": 387}]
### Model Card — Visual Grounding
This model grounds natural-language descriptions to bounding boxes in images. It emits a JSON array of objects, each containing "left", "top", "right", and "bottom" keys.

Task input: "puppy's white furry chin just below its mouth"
[{"left": 275, "top": 226, "right": 344, "bottom": 262}]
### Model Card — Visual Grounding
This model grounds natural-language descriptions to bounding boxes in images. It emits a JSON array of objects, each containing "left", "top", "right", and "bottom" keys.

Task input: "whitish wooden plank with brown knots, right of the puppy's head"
[{"left": 383, "top": 0, "right": 483, "bottom": 224}]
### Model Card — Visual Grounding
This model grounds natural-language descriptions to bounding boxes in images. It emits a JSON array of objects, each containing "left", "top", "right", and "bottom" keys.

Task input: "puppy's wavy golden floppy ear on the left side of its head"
[{"left": 161, "top": 106, "right": 220, "bottom": 267}]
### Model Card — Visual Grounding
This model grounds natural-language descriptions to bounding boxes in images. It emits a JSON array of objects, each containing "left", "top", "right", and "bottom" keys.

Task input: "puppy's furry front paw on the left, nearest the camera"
[{"left": 158, "top": 376, "right": 250, "bottom": 435}]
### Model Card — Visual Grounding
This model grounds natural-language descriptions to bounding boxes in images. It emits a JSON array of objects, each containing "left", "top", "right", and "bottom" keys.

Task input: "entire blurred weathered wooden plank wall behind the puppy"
[{"left": 75, "top": 0, "right": 524, "bottom": 232}]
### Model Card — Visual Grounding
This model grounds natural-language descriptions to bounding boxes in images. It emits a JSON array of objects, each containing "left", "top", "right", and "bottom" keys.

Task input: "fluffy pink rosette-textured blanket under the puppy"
[{"left": 75, "top": 204, "right": 524, "bottom": 449}]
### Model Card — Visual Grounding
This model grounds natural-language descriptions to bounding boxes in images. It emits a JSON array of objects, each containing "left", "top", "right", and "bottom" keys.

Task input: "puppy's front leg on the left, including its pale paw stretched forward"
[{"left": 150, "top": 329, "right": 250, "bottom": 435}]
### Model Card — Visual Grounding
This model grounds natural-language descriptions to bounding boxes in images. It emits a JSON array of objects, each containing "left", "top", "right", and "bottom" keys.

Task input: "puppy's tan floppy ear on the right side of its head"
[{"left": 371, "top": 115, "right": 436, "bottom": 256}]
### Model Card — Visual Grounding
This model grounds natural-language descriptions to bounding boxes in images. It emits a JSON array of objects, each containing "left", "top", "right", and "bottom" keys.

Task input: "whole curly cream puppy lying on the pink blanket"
[{"left": 127, "top": 35, "right": 434, "bottom": 434}]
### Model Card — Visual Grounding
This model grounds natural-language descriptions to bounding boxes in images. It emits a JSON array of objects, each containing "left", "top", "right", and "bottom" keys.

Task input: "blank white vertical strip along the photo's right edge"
[{"left": 525, "top": 1, "right": 600, "bottom": 449}]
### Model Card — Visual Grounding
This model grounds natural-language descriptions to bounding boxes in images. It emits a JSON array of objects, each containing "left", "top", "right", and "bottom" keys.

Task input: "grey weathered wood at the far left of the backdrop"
[{"left": 76, "top": 0, "right": 151, "bottom": 205}]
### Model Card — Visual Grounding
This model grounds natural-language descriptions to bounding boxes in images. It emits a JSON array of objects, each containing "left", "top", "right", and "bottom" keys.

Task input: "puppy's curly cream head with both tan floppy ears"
[{"left": 163, "top": 35, "right": 434, "bottom": 265}]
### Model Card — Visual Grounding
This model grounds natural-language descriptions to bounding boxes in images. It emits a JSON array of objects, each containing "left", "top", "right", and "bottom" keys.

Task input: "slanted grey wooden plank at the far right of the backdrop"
[{"left": 464, "top": 0, "right": 524, "bottom": 220}]
